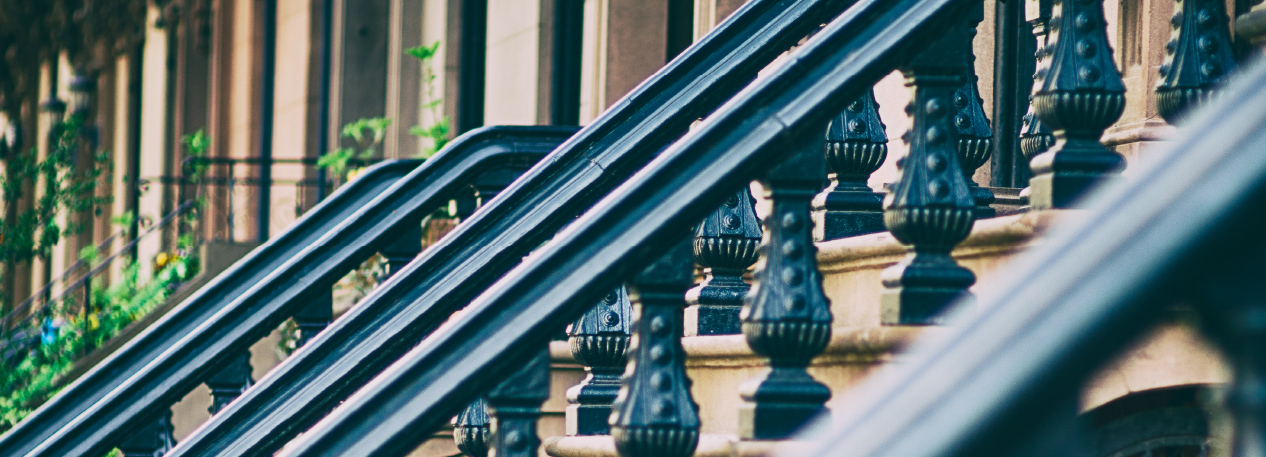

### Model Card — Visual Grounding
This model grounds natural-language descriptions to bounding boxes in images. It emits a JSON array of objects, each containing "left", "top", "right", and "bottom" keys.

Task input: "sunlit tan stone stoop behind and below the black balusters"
[{"left": 541, "top": 210, "right": 1229, "bottom": 457}]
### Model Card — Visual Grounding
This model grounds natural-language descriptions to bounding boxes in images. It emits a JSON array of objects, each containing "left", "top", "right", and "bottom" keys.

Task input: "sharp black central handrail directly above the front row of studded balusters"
[{"left": 274, "top": 0, "right": 979, "bottom": 457}]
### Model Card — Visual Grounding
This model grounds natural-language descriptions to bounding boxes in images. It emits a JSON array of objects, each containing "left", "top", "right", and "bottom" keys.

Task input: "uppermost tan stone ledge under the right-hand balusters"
[{"left": 818, "top": 210, "right": 1079, "bottom": 275}]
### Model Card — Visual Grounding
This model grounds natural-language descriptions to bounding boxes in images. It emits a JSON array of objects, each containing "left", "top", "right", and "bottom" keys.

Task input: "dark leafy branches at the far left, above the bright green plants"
[{"left": 0, "top": 116, "right": 111, "bottom": 309}]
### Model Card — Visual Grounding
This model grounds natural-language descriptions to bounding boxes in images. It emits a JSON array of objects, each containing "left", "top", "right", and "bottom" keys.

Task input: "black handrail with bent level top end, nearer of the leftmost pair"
[{"left": 7, "top": 127, "right": 576, "bottom": 456}]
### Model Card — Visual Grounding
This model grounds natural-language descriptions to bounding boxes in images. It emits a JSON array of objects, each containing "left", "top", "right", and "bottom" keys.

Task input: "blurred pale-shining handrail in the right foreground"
[{"left": 786, "top": 49, "right": 1266, "bottom": 457}]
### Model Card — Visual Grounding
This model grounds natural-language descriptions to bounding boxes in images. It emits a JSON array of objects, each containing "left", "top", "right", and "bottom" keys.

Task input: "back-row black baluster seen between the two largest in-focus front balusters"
[{"left": 813, "top": 89, "right": 887, "bottom": 241}]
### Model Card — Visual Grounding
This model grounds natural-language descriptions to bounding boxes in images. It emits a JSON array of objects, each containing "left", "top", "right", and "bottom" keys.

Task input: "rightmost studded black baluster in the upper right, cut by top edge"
[{"left": 1156, "top": 0, "right": 1236, "bottom": 124}]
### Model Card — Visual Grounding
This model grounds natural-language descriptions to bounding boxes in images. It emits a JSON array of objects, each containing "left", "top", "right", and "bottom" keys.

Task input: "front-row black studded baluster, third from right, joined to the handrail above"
[{"left": 880, "top": 13, "right": 976, "bottom": 325}]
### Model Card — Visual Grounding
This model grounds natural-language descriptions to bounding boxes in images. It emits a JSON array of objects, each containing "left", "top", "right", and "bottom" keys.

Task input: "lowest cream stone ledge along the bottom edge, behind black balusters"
[{"left": 544, "top": 433, "right": 812, "bottom": 457}]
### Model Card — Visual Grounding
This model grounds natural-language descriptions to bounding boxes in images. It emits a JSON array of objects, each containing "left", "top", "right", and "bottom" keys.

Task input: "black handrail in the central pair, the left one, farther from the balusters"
[{"left": 160, "top": 0, "right": 852, "bottom": 457}]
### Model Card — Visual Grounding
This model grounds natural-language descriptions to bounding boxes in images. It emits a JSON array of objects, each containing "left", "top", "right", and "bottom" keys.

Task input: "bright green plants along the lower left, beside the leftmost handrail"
[{"left": 0, "top": 241, "right": 199, "bottom": 433}]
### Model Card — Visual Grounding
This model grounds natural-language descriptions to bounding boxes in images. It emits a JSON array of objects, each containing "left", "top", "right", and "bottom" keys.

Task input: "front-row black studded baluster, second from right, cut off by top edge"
[{"left": 1029, "top": 0, "right": 1125, "bottom": 209}]
